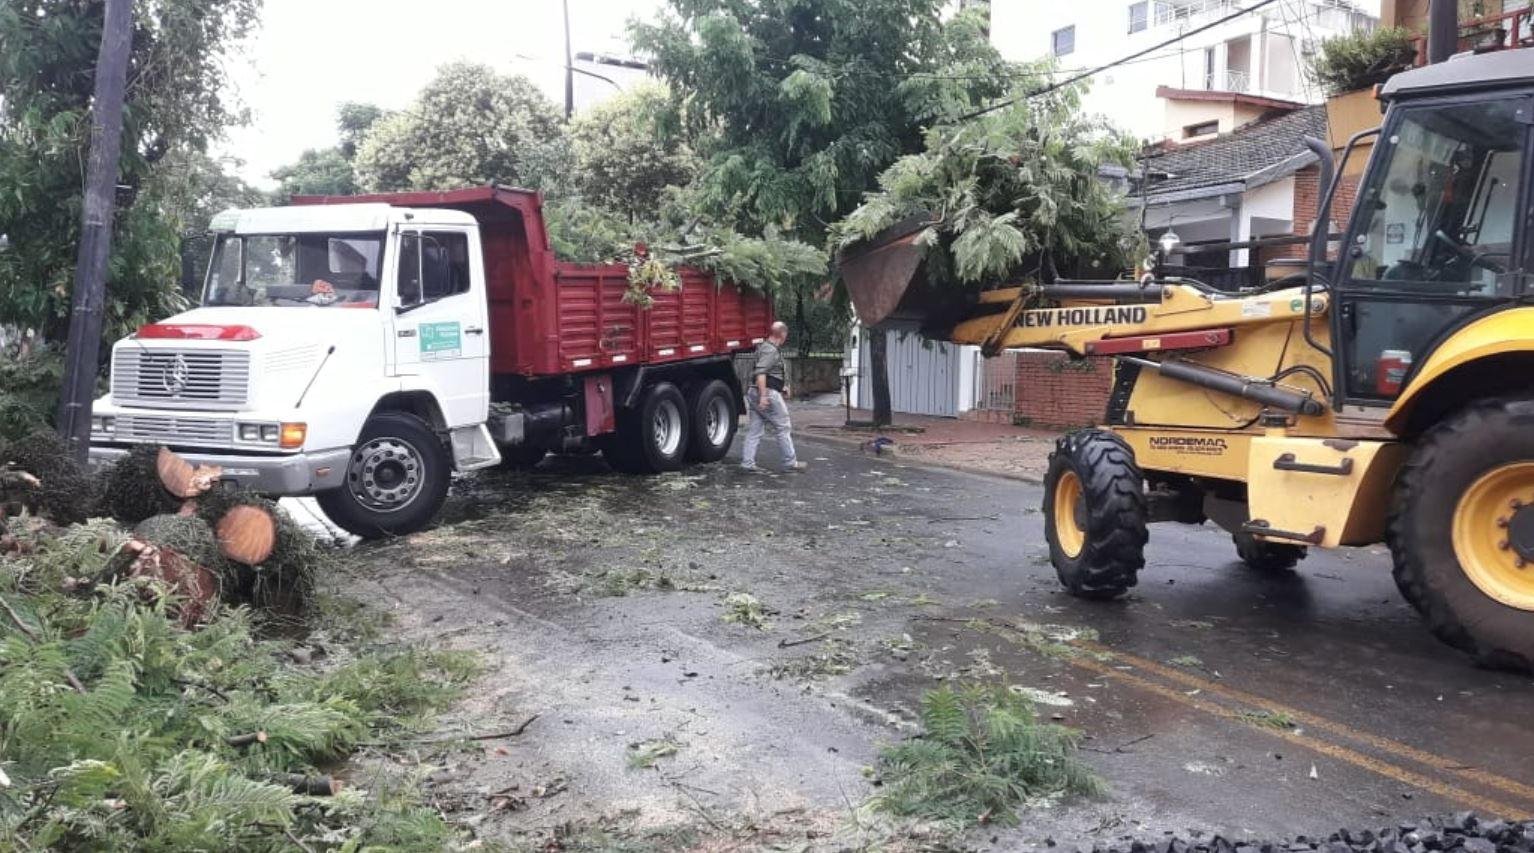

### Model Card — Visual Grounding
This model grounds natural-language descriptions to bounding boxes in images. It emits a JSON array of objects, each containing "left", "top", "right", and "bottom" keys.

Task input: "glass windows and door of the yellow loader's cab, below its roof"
[{"left": 1336, "top": 98, "right": 1528, "bottom": 402}]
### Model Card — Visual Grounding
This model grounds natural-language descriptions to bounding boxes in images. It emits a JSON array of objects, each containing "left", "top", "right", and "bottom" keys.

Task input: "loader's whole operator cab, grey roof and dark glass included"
[{"left": 1332, "top": 49, "right": 1534, "bottom": 407}]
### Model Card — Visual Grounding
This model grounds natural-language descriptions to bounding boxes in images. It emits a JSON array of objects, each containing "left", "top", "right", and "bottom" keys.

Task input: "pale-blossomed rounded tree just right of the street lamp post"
[{"left": 569, "top": 83, "right": 700, "bottom": 222}]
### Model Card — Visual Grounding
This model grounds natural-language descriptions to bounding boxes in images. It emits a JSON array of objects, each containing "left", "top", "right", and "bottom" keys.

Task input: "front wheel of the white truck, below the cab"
[{"left": 316, "top": 411, "right": 453, "bottom": 538}]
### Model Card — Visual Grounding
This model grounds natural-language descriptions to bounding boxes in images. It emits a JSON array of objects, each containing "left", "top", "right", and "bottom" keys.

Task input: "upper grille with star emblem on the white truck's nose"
[{"left": 112, "top": 347, "right": 250, "bottom": 408}]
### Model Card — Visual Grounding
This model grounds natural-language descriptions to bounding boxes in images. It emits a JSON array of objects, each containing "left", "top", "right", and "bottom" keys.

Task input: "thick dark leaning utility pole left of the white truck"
[{"left": 58, "top": 0, "right": 133, "bottom": 462}]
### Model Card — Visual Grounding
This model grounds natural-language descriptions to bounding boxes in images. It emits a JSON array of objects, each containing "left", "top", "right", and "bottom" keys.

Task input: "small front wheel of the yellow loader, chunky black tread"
[{"left": 1043, "top": 430, "right": 1149, "bottom": 598}]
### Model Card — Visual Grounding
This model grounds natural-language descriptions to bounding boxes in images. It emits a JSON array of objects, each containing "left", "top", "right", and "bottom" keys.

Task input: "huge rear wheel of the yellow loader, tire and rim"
[{"left": 1385, "top": 399, "right": 1534, "bottom": 672}]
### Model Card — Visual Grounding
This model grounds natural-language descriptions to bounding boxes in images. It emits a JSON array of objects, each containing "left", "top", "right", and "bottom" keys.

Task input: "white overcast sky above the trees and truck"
[{"left": 222, "top": 0, "right": 660, "bottom": 189}]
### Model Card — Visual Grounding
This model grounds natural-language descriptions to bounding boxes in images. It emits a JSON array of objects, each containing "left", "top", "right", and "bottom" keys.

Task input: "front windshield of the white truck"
[{"left": 202, "top": 233, "right": 384, "bottom": 308}]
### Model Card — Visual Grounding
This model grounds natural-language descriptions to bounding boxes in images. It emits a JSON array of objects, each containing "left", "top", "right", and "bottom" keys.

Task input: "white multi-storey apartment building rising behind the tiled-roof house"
[{"left": 991, "top": 0, "right": 1378, "bottom": 141}]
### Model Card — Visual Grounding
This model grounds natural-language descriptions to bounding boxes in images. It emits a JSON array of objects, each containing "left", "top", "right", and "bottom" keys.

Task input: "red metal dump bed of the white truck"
[{"left": 293, "top": 187, "right": 773, "bottom": 376}]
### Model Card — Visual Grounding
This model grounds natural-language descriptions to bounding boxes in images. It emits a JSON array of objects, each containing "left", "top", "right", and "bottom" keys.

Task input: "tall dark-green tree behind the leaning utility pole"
[{"left": 0, "top": 0, "right": 259, "bottom": 339}]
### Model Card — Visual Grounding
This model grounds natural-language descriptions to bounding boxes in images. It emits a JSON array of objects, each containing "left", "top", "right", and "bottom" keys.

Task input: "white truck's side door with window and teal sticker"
[{"left": 394, "top": 226, "right": 489, "bottom": 427}]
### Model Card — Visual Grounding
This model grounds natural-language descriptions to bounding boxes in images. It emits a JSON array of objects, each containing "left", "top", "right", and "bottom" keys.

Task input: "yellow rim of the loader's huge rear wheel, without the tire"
[{"left": 1454, "top": 462, "right": 1534, "bottom": 611}]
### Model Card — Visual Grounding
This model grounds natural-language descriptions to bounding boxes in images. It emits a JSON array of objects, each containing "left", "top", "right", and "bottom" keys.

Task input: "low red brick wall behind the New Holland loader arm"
[{"left": 1016, "top": 351, "right": 1114, "bottom": 430}]
